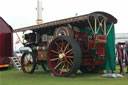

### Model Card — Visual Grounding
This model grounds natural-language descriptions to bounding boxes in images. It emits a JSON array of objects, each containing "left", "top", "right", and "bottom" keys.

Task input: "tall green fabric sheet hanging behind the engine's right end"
[{"left": 105, "top": 24, "right": 116, "bottom": 70}]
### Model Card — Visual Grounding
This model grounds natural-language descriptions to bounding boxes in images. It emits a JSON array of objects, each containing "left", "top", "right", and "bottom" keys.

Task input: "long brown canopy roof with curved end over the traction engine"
[{"left": 13, "top": 11, "right": 117, "bottom": 32}]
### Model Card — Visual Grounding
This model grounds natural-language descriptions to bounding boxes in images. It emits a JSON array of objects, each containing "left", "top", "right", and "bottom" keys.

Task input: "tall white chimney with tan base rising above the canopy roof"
[{"left": 36, "top": 0, "right": 43, "bottom": 24}]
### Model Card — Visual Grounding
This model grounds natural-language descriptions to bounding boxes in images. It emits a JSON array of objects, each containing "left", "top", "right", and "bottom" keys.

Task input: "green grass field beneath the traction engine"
[{"left": 0, "top": 69, "right": 128, "bottom": 85}]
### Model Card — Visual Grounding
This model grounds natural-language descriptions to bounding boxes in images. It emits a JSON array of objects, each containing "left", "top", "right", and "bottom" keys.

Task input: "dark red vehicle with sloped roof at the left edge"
[{"left": 0, "top": 17, "right": 13, "bottom": 68}]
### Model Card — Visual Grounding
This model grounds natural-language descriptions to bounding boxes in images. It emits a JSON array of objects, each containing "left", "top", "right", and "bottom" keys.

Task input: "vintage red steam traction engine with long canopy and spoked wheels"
[{"left": 14, "top": 12, "right": 116, "bottom": 77}]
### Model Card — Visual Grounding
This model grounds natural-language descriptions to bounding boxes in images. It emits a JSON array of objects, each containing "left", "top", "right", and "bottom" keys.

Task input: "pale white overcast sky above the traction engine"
[{"left": 0, "top": 0, "right": 128, "bottom": 33}]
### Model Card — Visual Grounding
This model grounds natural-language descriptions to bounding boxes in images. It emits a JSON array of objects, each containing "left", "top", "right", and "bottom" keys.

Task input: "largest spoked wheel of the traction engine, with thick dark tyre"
[{"left": 48, "top": 36, "right": 82, "bottom": 77}]
